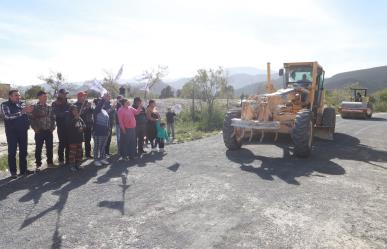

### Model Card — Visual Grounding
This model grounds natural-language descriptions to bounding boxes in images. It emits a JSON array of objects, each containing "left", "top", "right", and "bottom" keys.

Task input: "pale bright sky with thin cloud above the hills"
[{"left": 0, "top": 0, "right": 387, "bottom": 85}]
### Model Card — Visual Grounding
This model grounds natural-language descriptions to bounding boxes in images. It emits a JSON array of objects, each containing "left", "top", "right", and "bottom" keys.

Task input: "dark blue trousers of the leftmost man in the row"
[{"left": 5, "top": 129, "right": 28, "bottom": 175}]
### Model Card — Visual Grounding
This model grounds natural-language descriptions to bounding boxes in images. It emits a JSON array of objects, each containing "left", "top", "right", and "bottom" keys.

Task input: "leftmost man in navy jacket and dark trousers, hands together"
[{"left": 1, "top": 90, "right": 33, "bottom": 179}]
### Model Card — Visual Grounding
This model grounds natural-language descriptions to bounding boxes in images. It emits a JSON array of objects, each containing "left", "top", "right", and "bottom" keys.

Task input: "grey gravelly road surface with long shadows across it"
[{"left": 0, "top": 114, "right": 387, "bottom": 249}]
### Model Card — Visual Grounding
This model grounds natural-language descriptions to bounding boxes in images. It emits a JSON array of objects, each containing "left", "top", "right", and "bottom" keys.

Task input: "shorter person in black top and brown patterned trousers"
[{"left": 65, "top": 105, "right": 86, "bottom": 171}]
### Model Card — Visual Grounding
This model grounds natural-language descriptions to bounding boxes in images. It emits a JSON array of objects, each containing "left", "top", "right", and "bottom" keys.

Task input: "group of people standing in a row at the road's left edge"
[{"left": 1, "top": 89, "right": 175, "bottom": 178}]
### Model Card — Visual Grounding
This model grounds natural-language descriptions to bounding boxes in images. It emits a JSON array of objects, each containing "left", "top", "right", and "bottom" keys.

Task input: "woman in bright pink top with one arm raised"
[{"left": 117, "top": 99, "right": 142, "bottom": 160}]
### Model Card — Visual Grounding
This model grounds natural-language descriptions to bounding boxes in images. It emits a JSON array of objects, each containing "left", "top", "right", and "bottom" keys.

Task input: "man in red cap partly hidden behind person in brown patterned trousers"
[{"left": 75, "top": 92, "right": 93, "bottom": 159}]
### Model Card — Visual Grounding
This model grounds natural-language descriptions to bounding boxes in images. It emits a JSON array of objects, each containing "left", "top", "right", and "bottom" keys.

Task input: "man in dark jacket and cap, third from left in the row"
[{"left": 52, "top": 89, "right": 70, "bottom": 165}]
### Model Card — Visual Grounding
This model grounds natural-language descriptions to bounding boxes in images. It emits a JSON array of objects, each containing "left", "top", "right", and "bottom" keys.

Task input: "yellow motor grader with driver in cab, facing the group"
[{"left": 223, "top": 62, "right": 336, "bottom": 157}]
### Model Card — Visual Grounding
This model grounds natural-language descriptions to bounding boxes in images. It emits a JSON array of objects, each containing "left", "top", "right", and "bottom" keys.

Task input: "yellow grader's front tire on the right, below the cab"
[{"left": 292, "top": 110, "right": 313, "bottom": 157}]
